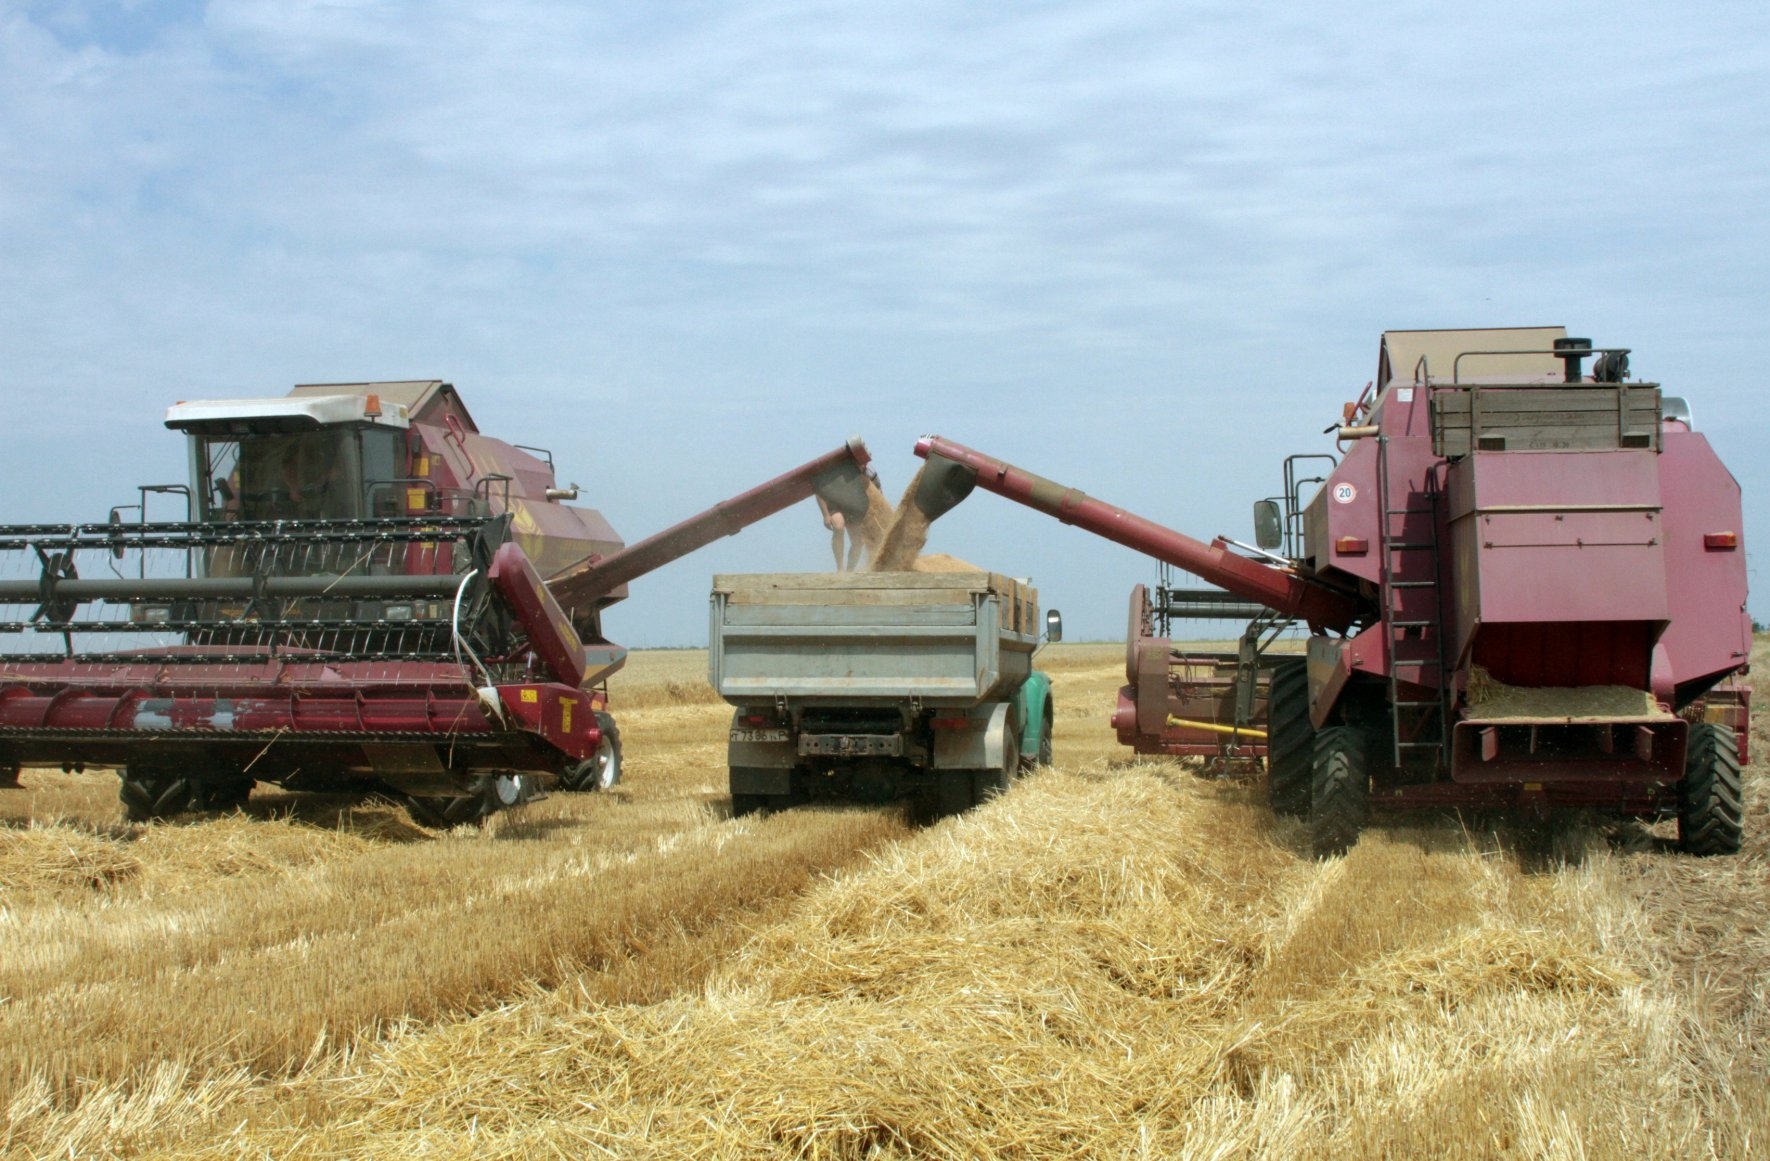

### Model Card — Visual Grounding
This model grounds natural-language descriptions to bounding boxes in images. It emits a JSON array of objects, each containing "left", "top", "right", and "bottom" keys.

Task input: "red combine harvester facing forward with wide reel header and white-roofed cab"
[{"left": 0, "top": 381, "right": 869, "bottom": 825}]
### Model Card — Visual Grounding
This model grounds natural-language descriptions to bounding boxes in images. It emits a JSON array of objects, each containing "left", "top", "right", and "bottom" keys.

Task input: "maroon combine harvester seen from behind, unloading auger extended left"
[{"left": 917, "top": 327, "right": 1752, "bottom": 855}]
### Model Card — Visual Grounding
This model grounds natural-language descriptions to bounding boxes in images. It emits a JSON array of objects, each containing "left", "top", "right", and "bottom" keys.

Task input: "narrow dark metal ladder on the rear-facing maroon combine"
[{"left": 1377, "top": 435, "right": 1451, "bottom": 770}]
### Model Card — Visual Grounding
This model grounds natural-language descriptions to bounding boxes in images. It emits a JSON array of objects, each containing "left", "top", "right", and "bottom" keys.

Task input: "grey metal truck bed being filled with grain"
[{"left": 708, "top": 572, "right": 1039, "bottom": 706}]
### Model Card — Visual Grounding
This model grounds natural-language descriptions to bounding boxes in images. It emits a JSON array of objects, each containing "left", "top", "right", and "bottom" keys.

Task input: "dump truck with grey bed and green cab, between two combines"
[{"left": 708, "top": 572, "right": 1062, "bottom": 818}]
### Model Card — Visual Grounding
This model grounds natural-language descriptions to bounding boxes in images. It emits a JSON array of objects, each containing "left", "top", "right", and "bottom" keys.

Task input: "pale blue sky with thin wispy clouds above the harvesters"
[{"left": 0, "top": 0, "right": 1770, "bottom": 646}]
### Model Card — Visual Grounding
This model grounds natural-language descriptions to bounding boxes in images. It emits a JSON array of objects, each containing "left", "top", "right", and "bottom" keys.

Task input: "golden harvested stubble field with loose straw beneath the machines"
[{"left": 0, "top": 646, "right": 1770, "bottom": 1161}]
